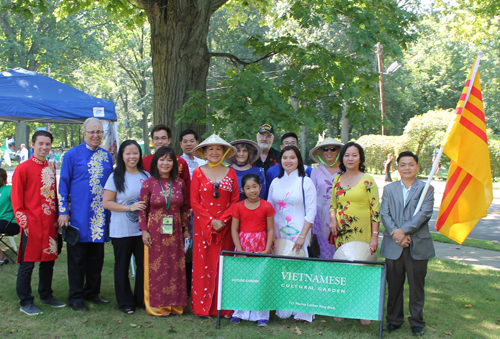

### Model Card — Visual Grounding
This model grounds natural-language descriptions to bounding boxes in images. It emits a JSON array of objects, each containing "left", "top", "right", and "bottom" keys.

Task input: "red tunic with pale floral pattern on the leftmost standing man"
[{"left": 11, "top": 156, "right": 58, "bottom": 263}]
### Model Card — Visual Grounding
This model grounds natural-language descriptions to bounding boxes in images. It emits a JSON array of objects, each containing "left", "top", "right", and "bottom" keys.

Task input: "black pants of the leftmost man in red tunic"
[{"left": 16, "top": 232, "right": 55, "bottom": 306}]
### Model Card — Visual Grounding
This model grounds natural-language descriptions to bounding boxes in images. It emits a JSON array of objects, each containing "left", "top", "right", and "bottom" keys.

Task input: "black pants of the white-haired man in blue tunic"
[{"left": 66, "top": 242, "right": 104, "bottom": 304}]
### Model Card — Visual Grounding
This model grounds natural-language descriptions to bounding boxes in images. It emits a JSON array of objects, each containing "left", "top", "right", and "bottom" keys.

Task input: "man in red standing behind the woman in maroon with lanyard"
[{"left": 142, "top": 124, "right": 191, "bottom": 208}]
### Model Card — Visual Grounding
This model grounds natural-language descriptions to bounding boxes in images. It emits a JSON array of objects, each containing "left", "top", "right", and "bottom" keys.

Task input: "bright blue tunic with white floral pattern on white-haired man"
[{"left": 59, "top": 142, "right": 113, "bottom": 243}]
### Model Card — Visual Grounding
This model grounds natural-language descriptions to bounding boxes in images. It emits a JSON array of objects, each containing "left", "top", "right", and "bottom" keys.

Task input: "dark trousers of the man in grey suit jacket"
[{"left": 385, "top": 247, "right": 429, "bottom": 327}]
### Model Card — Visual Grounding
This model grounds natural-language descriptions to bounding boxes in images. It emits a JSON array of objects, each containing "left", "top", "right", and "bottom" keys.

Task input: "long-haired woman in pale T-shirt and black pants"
[{"left": 102, "top": 140, "right": 149, "bottom": 314}]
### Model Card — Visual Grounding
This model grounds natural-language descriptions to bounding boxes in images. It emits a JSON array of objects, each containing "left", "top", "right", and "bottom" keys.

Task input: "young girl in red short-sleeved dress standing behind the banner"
[{"left": 231, "top": 174, "right": 276, "bottom": 326}]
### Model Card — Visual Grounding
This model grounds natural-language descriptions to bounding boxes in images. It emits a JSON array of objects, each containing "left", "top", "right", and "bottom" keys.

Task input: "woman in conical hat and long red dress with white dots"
[{"left": 191, "top": 134, "right": 240, "bottom": 318}]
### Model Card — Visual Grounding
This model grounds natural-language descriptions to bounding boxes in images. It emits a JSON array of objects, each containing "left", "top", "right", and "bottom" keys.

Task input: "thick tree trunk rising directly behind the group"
[{"left": 136, "top": 0, "right": 227, "bottom": 152}]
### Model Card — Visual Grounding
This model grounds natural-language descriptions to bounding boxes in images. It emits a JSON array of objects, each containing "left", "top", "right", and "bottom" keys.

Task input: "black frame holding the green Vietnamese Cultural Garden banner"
[{"left": 216, "top": 251, "right": 386, "bottom": 338}]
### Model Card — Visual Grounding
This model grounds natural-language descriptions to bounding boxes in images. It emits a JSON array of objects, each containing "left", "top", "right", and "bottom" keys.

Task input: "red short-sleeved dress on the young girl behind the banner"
[{"left": 232, "top": 199, "right": 276, "bottom": 253}]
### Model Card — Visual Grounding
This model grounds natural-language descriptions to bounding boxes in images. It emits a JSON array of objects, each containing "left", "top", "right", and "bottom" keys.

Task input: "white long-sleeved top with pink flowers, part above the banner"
[{"left": 267, "top": 170, "right": 317, "bottom": 250}]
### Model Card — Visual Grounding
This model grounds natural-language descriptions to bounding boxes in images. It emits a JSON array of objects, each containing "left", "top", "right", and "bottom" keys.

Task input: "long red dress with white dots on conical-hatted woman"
[{"left": 191, "top": 167, "right": 240, "bottom": 316}]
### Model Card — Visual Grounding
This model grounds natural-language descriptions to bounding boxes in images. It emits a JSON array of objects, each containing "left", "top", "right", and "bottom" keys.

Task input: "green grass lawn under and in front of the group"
[{"left": 0, "top": 244, "right": 500, "bottom": 339}]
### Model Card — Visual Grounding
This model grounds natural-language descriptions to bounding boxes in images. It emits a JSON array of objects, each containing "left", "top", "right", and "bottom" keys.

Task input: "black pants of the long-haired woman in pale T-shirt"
[{"left": 111, "top": 235, "right": 144, "bottom": 311}]
